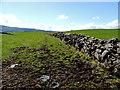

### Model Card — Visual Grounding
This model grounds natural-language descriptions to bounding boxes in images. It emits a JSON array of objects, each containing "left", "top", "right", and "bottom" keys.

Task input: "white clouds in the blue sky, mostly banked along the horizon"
[{"left": 0, "top": 14, "right": 118, "bottom": 31}]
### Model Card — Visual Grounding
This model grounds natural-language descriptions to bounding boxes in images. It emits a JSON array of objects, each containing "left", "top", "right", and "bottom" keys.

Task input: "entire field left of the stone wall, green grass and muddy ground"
[{"left": 2, "top": 32, "right": 120, "bottom": 88}]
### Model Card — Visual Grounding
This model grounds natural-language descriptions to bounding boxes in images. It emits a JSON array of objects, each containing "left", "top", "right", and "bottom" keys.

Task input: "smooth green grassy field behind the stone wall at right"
[{"left": 66, "top": 29, "right": 120, "bottom": 39}]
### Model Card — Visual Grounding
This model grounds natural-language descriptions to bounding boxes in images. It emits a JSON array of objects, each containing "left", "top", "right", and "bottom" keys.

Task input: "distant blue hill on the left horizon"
[{"left": 0, "top": 25, "right": 46, "bottom": 32}]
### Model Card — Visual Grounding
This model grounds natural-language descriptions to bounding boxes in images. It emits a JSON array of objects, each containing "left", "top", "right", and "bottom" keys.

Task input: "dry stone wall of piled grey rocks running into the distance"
[{"left": 50, "top": 32, "right": 120, "bottom": 76}]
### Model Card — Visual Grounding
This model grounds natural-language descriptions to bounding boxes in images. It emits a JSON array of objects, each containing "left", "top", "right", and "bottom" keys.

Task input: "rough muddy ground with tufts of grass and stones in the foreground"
[{"left": 2, "top": 45, "right": 120, "bottom": 89}]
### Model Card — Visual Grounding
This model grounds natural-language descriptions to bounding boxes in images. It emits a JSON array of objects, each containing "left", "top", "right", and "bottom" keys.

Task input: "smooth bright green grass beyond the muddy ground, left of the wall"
[{"left": 2, "top": 32, "right": 82, "bottom": 58}]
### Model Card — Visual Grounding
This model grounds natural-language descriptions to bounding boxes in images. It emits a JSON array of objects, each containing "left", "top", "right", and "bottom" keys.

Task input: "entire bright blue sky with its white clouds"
[{"left": 0, "top": 2, "right": 118, "bottom": 31}]
